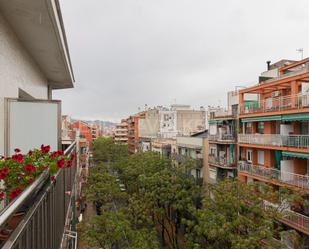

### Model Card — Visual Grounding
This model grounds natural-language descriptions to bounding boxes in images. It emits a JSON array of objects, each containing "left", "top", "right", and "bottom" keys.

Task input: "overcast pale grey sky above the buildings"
[{"left": 53, "top": 0, "right": 309, "bottom": 122}]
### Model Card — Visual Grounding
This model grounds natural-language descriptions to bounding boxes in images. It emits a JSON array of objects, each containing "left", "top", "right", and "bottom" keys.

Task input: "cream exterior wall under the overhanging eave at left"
[{"left": 0, "top": 13, "right": 48, "bottom": 155}]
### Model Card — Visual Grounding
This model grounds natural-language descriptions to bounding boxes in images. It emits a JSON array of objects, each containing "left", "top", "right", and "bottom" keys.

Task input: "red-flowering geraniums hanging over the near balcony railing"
[{"left": 0, "top": 145, "right": 74, "bottom": 200}]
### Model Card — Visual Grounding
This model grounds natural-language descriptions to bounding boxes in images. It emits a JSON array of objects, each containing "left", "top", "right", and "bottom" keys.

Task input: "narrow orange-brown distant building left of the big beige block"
[{"left": 126, "top": 112, "right": 145, "bottom": 154}]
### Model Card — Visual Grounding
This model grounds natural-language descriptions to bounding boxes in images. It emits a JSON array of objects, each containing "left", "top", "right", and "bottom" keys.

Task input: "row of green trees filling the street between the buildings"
[{"left": 80, "top": 138, "right": 304, "bottom": 249}]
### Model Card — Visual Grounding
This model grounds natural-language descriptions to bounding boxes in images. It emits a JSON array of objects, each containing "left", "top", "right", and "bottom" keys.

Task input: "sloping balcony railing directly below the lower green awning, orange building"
[{"left": 238, "top": 162, "right": 309, "bottom": 189}]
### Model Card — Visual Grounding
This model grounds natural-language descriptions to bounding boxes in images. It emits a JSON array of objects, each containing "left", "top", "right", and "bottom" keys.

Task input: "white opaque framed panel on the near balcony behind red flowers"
[{"left": 5, "top": 99, "right": 61, "bottom": 156}]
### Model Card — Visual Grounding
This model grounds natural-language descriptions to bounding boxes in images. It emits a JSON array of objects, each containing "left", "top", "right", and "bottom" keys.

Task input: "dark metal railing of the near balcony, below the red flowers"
[{"left": 0, "top": 142, "right": 78, "bottom": 249}]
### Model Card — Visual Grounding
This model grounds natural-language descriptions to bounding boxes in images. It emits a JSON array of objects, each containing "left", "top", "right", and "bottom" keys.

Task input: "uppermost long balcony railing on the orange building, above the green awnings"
[{"left": 240, "top": 94, "right": 309, "bottom": 114}]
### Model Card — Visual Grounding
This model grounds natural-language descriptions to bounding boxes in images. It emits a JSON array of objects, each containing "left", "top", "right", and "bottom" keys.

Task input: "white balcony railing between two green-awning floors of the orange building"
[{"left": 238, "top": 134, "right": 309, "bottom": 149}]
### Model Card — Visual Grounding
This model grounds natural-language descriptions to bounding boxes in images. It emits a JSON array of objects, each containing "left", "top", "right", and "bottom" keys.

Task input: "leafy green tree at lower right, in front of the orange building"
[{"left": 186, "top": 181, "right": 280, "bottom": 249}]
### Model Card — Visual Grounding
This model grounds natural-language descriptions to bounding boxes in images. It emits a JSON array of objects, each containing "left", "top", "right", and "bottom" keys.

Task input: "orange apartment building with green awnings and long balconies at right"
[{"left": 238, "top": 58, "right": 309, "bottom": 241}]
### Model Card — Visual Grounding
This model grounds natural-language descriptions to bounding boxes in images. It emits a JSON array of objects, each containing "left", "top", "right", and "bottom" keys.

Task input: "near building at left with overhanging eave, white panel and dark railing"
[{"left": 0, "top": 0, "right": 79, "bottom": 249}]
